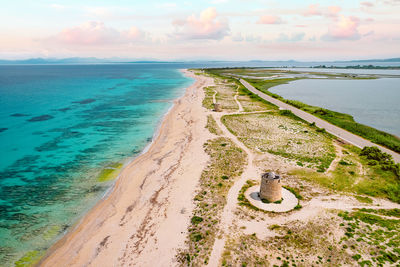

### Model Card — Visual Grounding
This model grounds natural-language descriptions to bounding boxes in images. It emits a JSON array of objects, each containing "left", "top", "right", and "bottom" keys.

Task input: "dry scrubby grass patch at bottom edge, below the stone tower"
[{"left": 222, "top": 217, "right": 355, "bottom": 266}]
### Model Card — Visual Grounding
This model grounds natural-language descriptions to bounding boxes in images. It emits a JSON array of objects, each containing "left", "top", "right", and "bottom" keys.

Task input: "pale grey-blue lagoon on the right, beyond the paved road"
[{"left": 270, "top": 78, "right": 400, "bottom": 136}]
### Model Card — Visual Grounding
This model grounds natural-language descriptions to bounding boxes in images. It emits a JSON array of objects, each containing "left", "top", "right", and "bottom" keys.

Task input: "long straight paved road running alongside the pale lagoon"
[{"left": 240, "top": 79, "right": 400, "bottom": 163}]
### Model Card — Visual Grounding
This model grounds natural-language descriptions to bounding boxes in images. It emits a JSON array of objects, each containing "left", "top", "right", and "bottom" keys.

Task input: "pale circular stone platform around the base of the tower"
[{"left": 244, "top": 185, "right": 299, "bottom": 212}]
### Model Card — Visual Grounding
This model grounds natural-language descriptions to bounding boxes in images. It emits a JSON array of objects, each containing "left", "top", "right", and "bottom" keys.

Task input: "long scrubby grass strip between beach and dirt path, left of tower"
[{"left": 177, "top": 137, "right": 247, "bottom": 266}]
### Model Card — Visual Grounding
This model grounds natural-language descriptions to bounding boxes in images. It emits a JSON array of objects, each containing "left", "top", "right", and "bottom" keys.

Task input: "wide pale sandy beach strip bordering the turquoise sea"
[{"left": 40, "top": 70, "right": 213, "bottom": 266}]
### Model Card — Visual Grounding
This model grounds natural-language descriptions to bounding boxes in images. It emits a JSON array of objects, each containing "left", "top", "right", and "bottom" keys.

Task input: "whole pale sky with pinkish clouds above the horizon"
[{"left": 0, "top": 0, "right": 400, "bottom": 61}]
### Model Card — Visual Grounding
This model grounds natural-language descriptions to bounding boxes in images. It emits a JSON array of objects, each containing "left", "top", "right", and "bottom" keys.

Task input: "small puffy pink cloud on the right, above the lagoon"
[{"left": 323, "top": 16, "right": 360, "bottom": 41}]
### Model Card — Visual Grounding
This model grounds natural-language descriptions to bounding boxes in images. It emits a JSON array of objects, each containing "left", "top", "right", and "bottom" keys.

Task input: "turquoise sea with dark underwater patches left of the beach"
[{"left": 0, "top": 64, "right": 192, "bottom": 266}]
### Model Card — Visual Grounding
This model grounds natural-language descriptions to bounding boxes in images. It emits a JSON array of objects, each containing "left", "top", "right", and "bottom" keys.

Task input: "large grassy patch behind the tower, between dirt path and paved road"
[{"left": 222, "top": 112, "right": 335, "bottom": 172}]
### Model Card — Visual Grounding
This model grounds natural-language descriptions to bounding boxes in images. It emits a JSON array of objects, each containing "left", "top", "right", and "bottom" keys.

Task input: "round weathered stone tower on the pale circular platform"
[{"left": 260, "top": 172, "right": 282, "bottom": 202}]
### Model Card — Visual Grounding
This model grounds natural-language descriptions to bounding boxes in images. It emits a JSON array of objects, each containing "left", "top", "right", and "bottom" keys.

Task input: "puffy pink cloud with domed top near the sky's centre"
[{"left": 172, "top": 7, "right": 230, "bottom": 40}]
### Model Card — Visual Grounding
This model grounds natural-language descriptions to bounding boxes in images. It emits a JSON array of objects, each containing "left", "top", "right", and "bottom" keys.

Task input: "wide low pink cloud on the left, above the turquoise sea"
[{"left": 51, "top": 21, "right": 144, "bottom": 46}]
